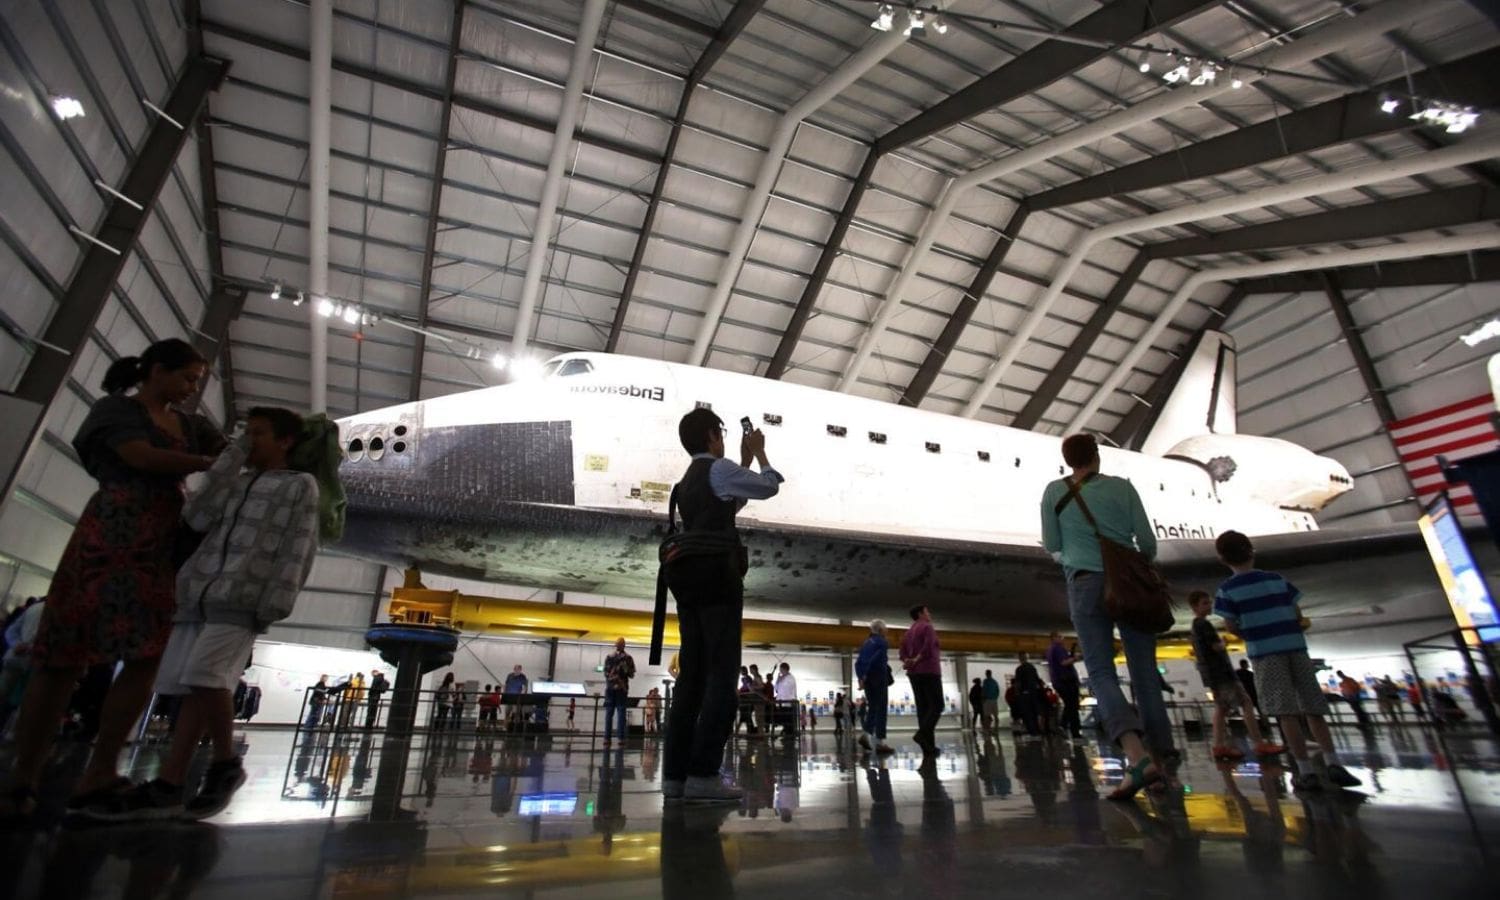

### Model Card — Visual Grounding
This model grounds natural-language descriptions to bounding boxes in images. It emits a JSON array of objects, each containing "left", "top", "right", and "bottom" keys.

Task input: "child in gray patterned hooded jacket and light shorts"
[{"left": 84, "top": 407, "right": 318, "bottom": 821}]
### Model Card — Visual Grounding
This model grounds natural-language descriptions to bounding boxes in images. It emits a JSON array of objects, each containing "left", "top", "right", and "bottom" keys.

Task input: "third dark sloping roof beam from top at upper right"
[{"left": 1145, "top": 185, "right": 1500, "bottom": 260}]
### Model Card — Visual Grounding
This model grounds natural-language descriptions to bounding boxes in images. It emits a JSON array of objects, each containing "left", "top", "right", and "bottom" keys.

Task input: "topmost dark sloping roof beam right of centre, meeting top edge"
[{"left": 875, "top": 0, "right": 1223, "bottom": 155}]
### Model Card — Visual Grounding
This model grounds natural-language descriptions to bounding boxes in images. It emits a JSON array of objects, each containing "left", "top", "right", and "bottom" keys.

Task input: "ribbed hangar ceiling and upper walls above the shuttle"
[{"left": 0, "top": 0, "right": 1500, "bottom": 618}]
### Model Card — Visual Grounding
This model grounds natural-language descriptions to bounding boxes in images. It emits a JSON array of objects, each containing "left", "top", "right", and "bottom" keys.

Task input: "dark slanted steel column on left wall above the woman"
[{"left": 0, "top": 56, "right": 230, "bottom": 497}]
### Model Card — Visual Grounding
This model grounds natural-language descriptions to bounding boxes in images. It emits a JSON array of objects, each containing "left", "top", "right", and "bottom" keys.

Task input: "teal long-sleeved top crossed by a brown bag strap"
[{"left": 1041, "top": 476, "right": 1157, "bottom": 575}]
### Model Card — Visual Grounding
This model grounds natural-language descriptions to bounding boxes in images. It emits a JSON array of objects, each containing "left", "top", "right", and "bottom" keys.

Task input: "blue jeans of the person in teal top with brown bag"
[{"left": 1068, "top": 572, "right": 1172, "bottom": 753}]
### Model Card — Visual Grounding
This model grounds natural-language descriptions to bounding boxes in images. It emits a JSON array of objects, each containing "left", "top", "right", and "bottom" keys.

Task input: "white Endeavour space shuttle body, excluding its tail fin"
[{"left": 331, "top": 353, "right": 1349, "bottom": 627}]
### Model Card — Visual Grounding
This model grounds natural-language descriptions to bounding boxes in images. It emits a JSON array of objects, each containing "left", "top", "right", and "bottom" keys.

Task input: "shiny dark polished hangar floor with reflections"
[{"left": 0, "top": 728, "right": 1500, "bottom": 900}]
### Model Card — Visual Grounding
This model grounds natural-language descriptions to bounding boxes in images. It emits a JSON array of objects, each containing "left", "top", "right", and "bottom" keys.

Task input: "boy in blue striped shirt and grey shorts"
[{"left": 1214, "top": 531, "right": 1361, "bottom": 791}]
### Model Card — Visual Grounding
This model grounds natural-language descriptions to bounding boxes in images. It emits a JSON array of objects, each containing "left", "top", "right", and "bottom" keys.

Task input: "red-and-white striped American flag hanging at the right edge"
[{"left": 1388, "top": 395, "right": 1500, "bottom": 518}]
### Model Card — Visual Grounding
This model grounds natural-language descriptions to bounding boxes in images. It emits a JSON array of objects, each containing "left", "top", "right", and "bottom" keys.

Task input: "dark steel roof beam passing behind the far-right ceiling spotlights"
[{"left": 1032, "top": 48, "right": 1500, "bottom": 210}]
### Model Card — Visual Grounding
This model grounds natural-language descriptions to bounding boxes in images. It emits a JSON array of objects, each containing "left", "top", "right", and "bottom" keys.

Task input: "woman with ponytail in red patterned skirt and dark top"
[{"left": 2, "top": 339, "right": 225, "bottom": 815}]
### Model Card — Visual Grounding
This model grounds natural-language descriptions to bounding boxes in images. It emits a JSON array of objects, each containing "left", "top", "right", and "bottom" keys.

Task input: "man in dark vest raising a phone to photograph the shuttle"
[{"left": 657, "top": 408, "right": 783, "bottom": 803}]
